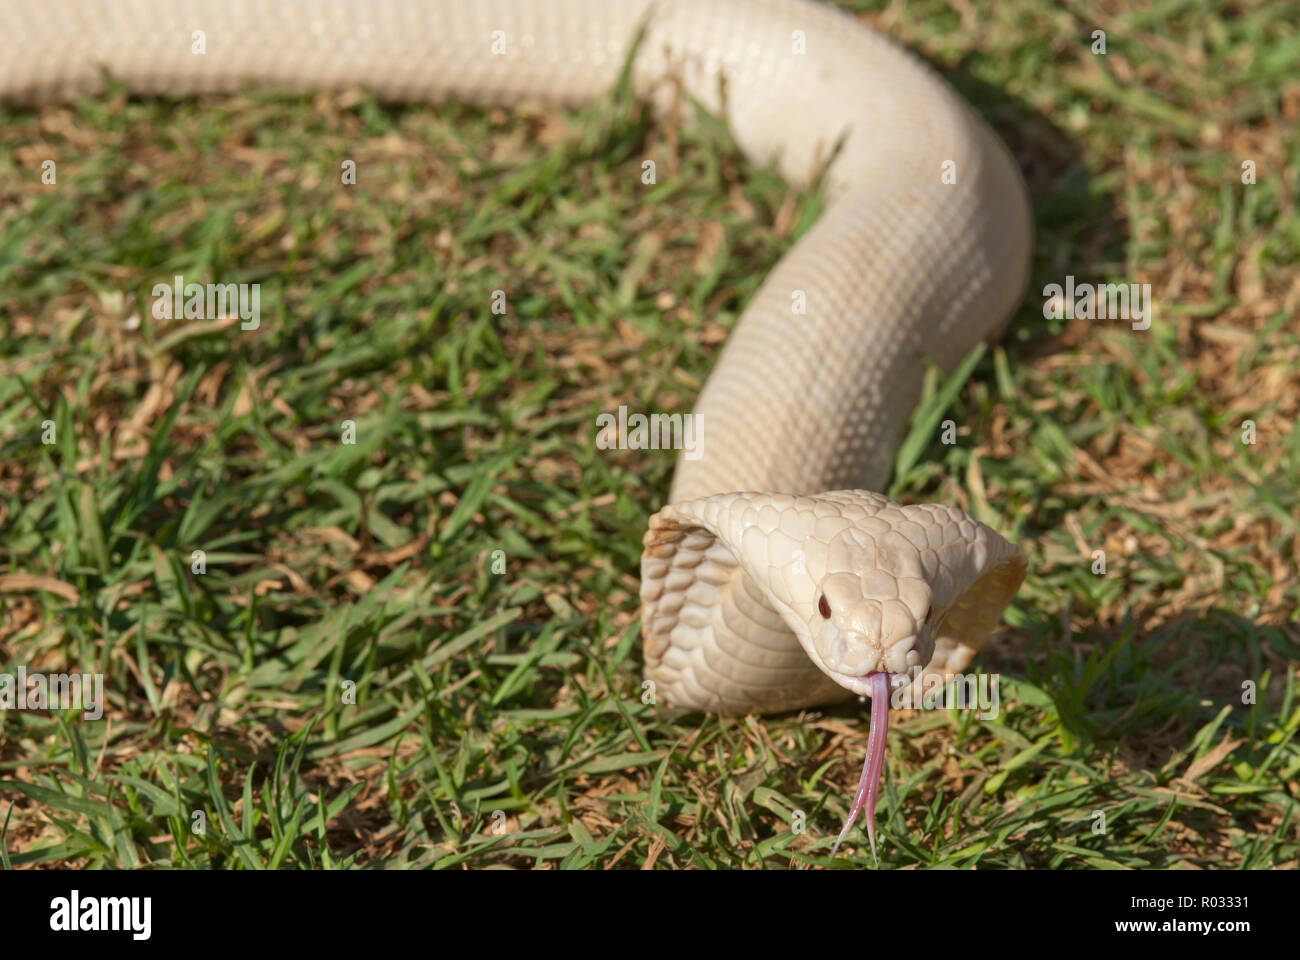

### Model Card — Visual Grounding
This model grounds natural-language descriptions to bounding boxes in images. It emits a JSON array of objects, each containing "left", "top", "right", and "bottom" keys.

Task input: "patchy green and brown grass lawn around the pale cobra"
[{"left": 0, "top": 0, "right": 1300, "bottom": 869}]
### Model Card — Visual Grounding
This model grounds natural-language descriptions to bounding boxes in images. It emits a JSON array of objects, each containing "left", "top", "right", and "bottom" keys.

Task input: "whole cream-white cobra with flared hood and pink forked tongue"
[{"left": 0, "top": 0, "right": 1032, "bottom": 862}]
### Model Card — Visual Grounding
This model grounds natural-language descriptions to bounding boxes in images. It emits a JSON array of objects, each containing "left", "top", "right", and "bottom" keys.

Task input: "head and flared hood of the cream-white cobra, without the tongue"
[{"left": 641, "top": 490, "right": 1026, "bottom": 710}]
